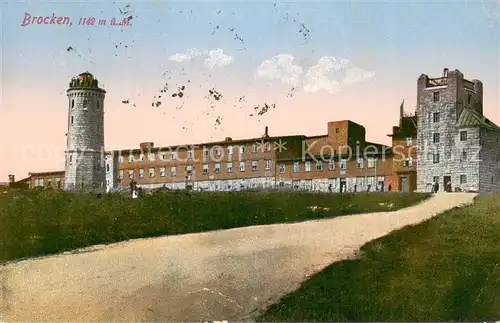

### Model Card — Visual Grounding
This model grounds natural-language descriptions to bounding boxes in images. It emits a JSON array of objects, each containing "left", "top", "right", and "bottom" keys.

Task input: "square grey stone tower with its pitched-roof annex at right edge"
[{"left": 416, "top": 69, "right": 500, "bottom": 193}]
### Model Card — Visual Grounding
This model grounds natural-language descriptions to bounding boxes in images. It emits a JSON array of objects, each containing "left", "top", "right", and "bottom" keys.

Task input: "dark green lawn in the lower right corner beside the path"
[{"left": 258, "top": 196, "right": 500, "bottom": 322}]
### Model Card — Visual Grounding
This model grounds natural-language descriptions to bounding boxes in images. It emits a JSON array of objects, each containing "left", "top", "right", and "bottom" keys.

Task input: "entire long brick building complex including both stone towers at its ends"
[{"left": 15, "top": 69, "right": 500, "bottom": 193}]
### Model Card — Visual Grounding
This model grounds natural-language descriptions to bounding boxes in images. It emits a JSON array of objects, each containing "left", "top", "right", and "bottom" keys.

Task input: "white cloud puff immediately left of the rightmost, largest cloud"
[{"left": 254, "top": 54, "right": 302, "bottom": 85}]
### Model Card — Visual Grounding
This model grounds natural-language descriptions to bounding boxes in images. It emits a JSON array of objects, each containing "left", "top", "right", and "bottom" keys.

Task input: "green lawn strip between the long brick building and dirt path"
[{"left": 0, "top": 190, "right": 429, "bottom": 262}]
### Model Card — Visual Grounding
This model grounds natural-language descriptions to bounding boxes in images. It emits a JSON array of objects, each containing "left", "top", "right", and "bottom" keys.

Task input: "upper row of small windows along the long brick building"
[{"left": 118, "top": 143, "right": 271, "bottom": 164}]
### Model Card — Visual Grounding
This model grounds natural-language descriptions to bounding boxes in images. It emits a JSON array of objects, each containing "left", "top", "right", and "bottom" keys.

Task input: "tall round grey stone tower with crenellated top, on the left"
[{"left": 64, "top": 72, "right": 106, "bottom": 191}]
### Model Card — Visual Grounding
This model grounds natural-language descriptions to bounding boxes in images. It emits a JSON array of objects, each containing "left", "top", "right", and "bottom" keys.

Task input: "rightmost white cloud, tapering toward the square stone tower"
[{"left": 304, "top": 56, "right": 375, "bottom": 93}]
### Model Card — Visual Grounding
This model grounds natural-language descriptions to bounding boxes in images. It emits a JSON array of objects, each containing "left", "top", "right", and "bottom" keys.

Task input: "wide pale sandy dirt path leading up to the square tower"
[{"left": 0, "top": 193, "right": 475, "bottom": 322}]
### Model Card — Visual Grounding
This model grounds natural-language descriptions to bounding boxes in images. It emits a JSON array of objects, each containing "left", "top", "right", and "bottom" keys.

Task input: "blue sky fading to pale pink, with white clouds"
[{"left": 0, "top": 0, "right": 500, "bottom": 182}]
